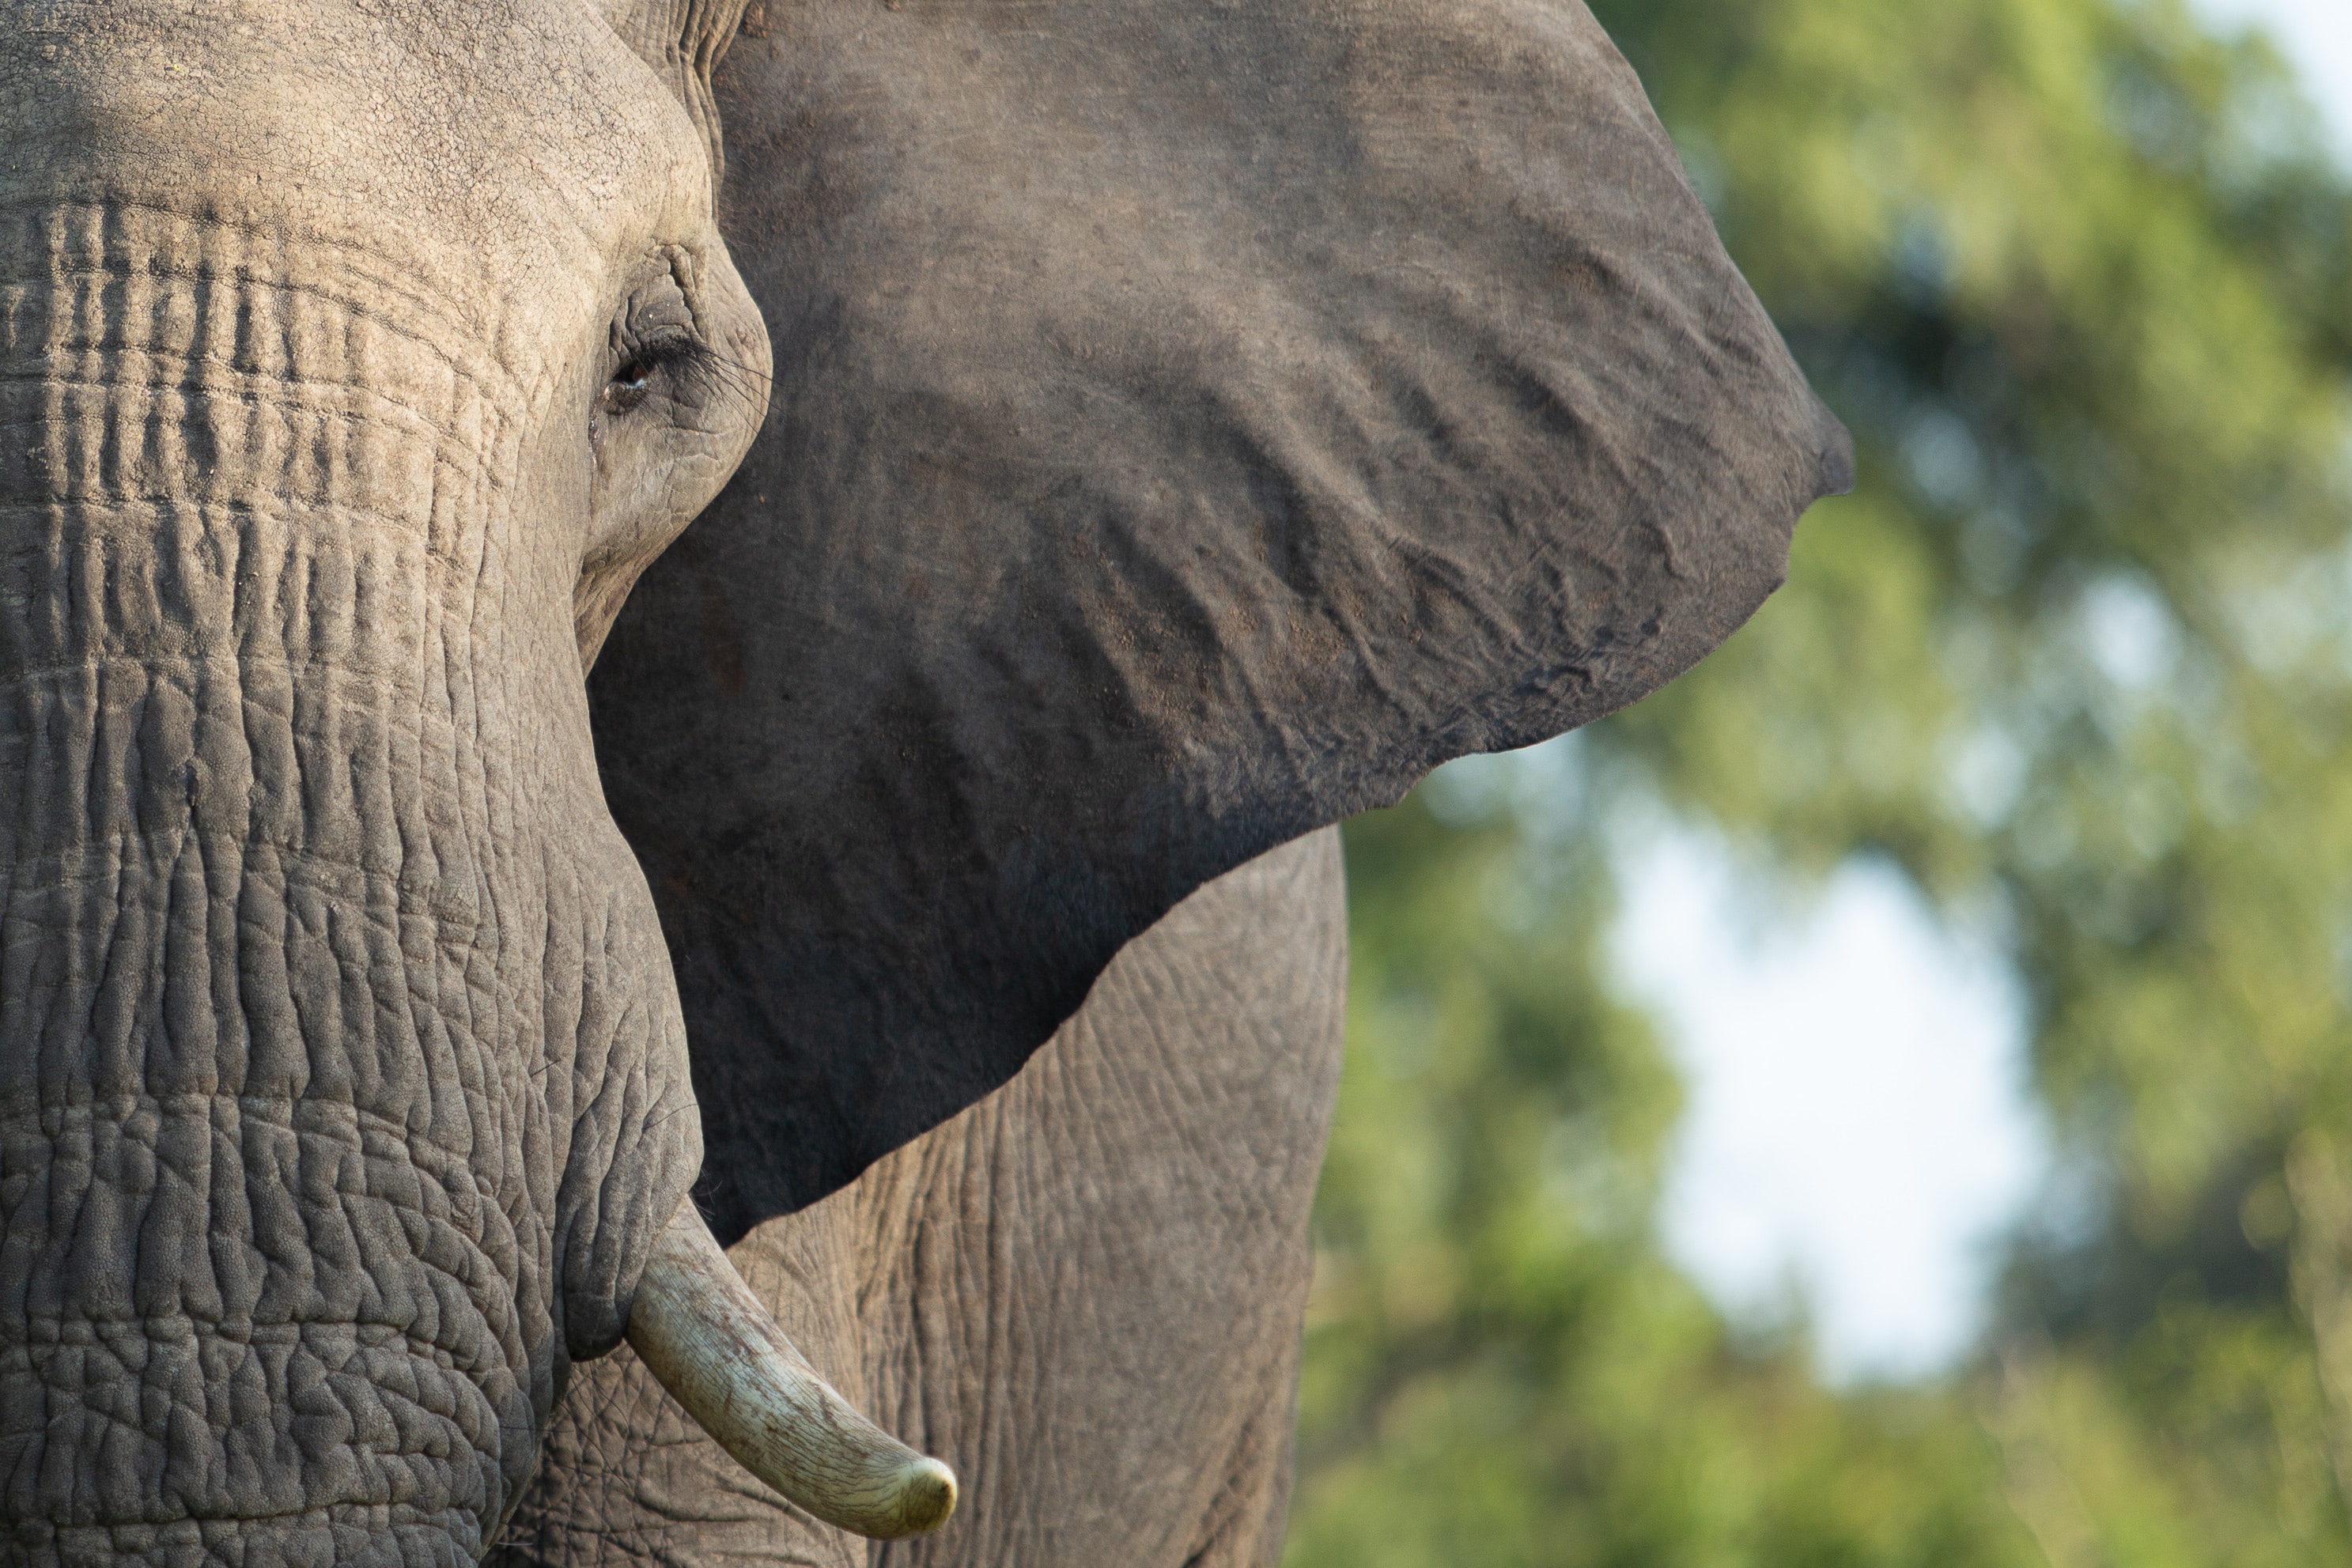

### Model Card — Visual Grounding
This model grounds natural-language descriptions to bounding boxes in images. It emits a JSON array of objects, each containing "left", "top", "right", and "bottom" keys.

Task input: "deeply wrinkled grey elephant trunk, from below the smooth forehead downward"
[{"left": 0, "top": 210, "right": 701, "bottom": 1563}]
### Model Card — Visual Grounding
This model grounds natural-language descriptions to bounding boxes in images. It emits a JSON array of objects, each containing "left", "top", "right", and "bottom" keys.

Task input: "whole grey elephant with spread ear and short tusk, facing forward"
[{"left": 0, "top": 0, "right": 1851, "bottom": 1568}]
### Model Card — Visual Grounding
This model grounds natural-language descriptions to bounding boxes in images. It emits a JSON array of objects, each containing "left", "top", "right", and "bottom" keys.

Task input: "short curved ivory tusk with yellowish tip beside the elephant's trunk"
[{"left": 628, "top": 1199, "right": 955, "bottom": 1540}]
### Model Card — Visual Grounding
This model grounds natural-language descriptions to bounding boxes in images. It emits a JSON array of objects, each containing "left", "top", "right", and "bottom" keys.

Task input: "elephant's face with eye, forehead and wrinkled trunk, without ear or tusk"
[{"left": 0, "top": 0, "right": 767, "bottom": 1561}]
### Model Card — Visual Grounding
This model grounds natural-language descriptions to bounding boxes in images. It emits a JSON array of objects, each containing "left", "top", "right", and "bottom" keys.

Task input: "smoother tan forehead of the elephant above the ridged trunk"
[{"left": 0, "top": 0, "right": 710, "bottom": 305}]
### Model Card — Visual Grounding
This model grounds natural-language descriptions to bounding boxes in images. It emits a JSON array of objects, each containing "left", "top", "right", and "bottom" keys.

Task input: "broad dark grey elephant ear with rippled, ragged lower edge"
[{"left": 578, "top": 0, "right": 1851, "bottom": 1234}]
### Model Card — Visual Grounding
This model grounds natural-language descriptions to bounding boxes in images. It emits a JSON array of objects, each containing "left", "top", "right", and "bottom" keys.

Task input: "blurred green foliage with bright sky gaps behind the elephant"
[{"left": 1284, "top": 0, "right": 2352, "bottom": 1568}]
